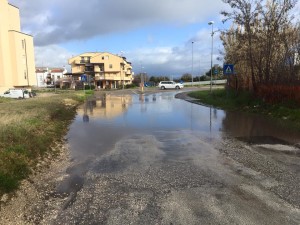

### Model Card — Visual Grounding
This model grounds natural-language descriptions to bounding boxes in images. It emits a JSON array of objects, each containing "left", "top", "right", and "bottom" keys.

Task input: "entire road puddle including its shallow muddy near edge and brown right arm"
[{"left": 62, "top": 92, "right": 300, "bottom": 196}]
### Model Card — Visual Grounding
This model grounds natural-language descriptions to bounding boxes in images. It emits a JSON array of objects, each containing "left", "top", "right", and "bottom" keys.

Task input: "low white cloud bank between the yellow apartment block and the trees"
[{"left": 126, "top": 29, "right": 222, "bottom": 77}]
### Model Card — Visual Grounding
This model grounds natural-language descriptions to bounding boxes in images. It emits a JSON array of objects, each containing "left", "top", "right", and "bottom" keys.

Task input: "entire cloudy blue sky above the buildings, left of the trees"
[{"left": 8, "top": 0, "right": 299, "bottom": 77}]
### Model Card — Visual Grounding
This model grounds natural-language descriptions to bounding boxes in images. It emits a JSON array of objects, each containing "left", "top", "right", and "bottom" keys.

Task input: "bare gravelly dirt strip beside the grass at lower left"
[{"left": 0, "top": 143, "right": 70, "bottom": 225}]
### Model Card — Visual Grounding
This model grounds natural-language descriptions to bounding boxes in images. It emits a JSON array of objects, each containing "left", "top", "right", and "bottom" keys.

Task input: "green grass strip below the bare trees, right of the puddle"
[{"left": 188, "top": 89, "right": 300, "bottom": 131}]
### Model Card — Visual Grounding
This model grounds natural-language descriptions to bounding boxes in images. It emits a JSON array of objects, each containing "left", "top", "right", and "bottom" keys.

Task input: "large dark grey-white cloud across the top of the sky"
[{"left": 9, "top": 0, "right": 222, "bottom": 46}]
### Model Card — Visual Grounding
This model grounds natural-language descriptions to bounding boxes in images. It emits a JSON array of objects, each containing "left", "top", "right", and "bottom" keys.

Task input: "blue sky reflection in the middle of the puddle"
[{"left": 84, "top": 93, "right": 224, "bottom": 134}]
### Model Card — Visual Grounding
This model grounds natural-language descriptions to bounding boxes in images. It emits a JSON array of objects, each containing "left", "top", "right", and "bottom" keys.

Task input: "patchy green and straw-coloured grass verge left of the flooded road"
[{"left": 0, "top": 91, "right": 88, "bottom": 193}]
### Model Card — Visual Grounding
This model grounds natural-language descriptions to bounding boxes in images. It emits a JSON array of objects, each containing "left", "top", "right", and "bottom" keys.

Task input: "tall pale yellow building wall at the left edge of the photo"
[{"left": 0, "top": 0, "right": 37, "bottom": 92}]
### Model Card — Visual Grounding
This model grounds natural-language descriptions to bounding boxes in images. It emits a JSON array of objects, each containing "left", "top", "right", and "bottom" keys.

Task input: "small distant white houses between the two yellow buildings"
[{"left": 35, "top": 67, "right": 67, "bottom": 87}]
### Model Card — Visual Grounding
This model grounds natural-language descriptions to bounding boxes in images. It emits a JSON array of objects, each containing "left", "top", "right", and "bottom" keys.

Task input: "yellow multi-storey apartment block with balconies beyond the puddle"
[{"left": 69, "top": 52, "right": 133, "bottom": 88}]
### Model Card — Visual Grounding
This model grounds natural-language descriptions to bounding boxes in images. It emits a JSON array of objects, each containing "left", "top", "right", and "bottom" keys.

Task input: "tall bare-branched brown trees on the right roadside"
[{"left": 221, "top": 0, "right": 299, "bottom": 90}]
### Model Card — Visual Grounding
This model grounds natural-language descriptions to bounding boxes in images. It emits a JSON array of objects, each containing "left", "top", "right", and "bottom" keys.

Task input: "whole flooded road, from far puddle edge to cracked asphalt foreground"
[{"left": 7, "top": 92, "right": 300, "bottom": 225}]
